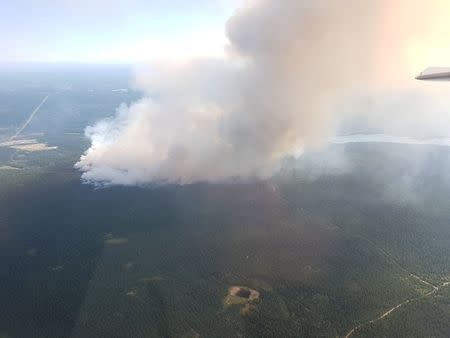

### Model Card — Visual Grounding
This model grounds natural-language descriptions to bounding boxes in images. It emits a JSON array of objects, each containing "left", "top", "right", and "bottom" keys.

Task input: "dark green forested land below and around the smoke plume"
[{"left": 0, "top": 67, "right": 450, "bottom": 338}]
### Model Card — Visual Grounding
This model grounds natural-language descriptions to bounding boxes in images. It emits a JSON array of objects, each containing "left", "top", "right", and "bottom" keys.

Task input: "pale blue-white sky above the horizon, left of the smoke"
[{"left": 0, "top": 0, "right": 240, "bottom": 63}]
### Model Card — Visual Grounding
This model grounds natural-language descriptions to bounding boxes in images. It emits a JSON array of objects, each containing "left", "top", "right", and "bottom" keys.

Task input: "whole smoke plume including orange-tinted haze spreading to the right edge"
[{"left": 76, "top": 0, "right": 450, "bottom": 185}]
